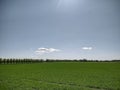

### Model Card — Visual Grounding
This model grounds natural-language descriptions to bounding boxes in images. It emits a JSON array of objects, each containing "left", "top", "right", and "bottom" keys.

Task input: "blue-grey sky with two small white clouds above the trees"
[{"left": 0, "top": 0, "right": 120, "bottom": 60}]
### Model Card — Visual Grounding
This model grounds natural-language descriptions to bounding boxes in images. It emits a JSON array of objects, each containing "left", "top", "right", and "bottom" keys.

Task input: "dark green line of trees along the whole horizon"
[{"left": 0, "top": 58, "right": 120, "bottom": 64}]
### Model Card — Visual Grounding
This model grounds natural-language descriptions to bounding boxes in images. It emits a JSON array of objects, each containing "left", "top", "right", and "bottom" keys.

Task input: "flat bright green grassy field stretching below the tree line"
[{"left": 0, "top": 62, "right": 120, "bottom": 90}]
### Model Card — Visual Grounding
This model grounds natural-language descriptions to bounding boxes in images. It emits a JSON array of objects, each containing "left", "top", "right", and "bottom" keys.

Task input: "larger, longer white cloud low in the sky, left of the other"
[{"left": 35, "top": 48, "right": 60, "bottom": 54}]
